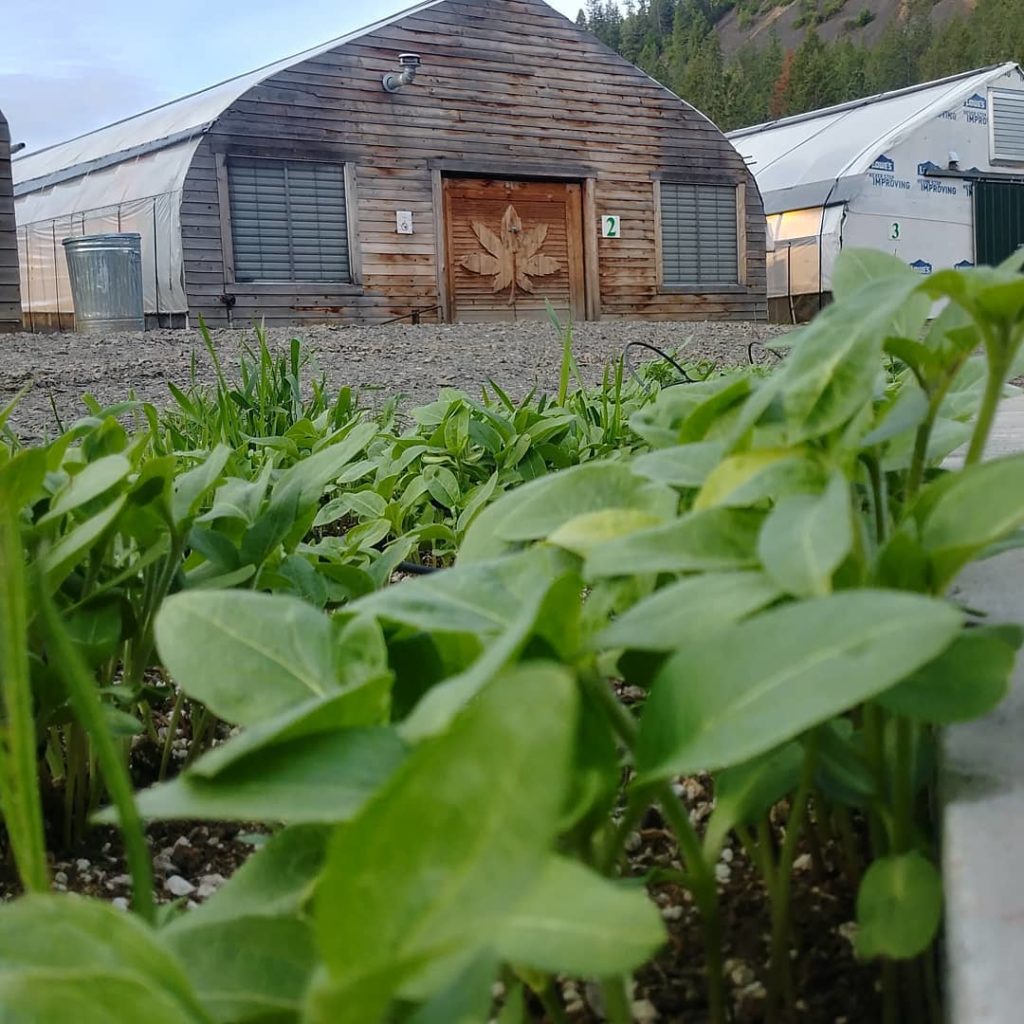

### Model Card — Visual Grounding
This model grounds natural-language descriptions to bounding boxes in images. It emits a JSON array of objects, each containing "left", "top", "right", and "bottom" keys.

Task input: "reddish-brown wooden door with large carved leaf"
[{"left": 444, "top": 178, "right": 586, "bottom": 323}]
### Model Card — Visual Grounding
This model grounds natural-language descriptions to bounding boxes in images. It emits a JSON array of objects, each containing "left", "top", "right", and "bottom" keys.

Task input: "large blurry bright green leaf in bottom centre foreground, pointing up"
[{"left": 315, "top": 663, "right": 577, "bottom": 998}]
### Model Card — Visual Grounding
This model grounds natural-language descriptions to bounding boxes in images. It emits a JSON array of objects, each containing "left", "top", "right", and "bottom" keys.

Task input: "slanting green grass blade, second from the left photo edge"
[{"left": 38, "top": 580, "right": 157, "bottom": 924}]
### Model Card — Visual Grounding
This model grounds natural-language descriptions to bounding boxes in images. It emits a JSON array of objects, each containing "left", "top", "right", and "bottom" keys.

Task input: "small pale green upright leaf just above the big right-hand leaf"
[{"left": 758, "top": 473, "right": 853, "bottom": 597}]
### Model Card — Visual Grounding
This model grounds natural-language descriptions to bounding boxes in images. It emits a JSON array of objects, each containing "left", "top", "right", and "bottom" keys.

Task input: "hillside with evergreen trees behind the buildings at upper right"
[{"left": 578, "top": 0, "right": 1024, "bottom": 130}]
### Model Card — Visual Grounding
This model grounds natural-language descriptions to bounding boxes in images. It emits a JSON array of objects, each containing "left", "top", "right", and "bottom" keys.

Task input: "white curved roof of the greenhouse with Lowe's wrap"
[{"left": 728, "top": 62, "right": 1024, "bottom": 213}]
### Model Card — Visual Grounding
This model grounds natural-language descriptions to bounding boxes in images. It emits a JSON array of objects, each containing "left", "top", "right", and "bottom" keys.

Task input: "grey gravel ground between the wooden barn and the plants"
[{"left": 0, "top": 321, "right": 786, "bottom": 440}]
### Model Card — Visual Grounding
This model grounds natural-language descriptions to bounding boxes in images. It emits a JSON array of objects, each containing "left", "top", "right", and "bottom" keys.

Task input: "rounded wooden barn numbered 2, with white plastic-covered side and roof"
[{"left": 14, "top": 0, "right": 766, "bottom": 327}]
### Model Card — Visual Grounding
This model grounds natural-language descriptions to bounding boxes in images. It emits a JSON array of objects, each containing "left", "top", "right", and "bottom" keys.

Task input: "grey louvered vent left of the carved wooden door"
[{"left": 227, "top": 158, "right": 350, "bottom": 283}]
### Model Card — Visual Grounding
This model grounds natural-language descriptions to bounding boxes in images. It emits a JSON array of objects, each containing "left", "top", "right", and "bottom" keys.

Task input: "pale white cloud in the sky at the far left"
[{"left": 0, "top": 65, "right": 163, "bottom": 150}]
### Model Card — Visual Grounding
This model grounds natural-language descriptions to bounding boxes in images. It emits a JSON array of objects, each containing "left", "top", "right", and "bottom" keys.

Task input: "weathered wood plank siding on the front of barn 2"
[{"left": 181, "top": 0, "right": 766, "bottom": 326}]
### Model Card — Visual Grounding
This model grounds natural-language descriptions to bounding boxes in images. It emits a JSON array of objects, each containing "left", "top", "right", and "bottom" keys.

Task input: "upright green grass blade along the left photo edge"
[{"left": 0, "top": 502, "right": 50, "bottom": 892}]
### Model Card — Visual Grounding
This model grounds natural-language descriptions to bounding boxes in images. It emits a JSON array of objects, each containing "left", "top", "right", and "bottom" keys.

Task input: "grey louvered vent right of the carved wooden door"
[{"left": 662, "top": 181, "right": 739, "bottom": 287}]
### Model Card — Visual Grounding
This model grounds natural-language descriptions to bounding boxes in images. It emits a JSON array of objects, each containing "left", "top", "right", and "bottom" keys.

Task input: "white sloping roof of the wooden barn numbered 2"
[{"left": 12, "top": 0, "right": 443, "bottom": 202}]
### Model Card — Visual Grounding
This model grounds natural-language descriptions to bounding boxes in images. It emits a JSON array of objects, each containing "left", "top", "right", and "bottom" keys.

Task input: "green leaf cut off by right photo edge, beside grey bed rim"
[{"left": 916, "top": 455, "right": 1024, "bottom": 587}]
